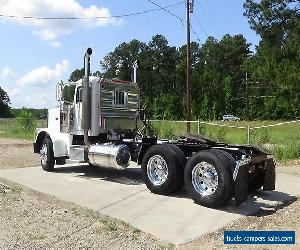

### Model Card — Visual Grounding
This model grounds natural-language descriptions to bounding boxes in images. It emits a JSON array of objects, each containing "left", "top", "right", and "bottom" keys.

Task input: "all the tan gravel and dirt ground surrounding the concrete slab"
[{"left": 0, "top": 139, "right": 300, "bottom": 249}]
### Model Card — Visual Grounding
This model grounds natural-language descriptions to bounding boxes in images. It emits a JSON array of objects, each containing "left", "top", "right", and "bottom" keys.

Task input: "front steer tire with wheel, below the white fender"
[{"left": 40, "top": 137, "right": 55, "bottom": 172}]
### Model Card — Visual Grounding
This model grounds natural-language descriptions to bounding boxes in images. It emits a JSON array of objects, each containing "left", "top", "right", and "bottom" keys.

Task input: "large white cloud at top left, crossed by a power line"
[{"left": 0, "top": 0, "right": 120, "bottom": 42}]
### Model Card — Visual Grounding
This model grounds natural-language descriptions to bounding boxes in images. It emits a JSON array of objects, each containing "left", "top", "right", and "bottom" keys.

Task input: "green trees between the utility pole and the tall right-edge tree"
[{"left": 188, "top": 34, "right": 250, "bottom": 119}]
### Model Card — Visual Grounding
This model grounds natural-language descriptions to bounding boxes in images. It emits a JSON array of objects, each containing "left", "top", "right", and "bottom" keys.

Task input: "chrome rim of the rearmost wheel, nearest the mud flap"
[{"left": 192, "top": 161, "right": 218, "bottom": 196}]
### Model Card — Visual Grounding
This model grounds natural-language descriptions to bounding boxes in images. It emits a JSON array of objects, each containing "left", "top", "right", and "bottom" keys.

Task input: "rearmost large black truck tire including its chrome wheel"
[{"left": 184, "top": 150, "right": 234, "bottom": 208}]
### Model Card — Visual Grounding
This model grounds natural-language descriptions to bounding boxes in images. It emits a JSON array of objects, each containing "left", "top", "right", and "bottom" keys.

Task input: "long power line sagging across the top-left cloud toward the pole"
[{"left": 0, "top": 1, "right": 185, "bottom": 20}]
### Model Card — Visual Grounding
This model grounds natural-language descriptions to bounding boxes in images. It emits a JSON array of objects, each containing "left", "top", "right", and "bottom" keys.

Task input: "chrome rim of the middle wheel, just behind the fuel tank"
[{"left": 147, "top": 155, "right": 168, "bottom": 186}]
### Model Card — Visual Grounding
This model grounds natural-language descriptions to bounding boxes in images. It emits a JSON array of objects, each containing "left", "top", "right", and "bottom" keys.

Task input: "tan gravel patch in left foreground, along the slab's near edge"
[{"left": 0, "top": 184, "right": 171, "bottom": 249}]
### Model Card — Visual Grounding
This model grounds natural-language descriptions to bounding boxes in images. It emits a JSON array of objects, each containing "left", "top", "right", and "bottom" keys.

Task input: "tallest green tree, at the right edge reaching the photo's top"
[{"left": 244, "top": 0, "right": 300, "bottom": 119}]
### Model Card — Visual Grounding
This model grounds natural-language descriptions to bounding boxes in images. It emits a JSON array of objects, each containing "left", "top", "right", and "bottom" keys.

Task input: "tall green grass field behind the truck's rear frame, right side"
[{"left": 151, "top": 121, "right": 300, "bottom": 162}]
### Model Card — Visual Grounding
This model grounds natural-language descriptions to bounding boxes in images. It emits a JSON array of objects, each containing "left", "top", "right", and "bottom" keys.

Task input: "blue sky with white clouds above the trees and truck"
[{"left": 0, "top": 0, "right": 259, "bottom": 108}]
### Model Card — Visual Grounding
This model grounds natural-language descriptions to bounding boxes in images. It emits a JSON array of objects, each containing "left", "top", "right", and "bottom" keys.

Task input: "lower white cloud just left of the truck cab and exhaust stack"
[{"left": 17, "top": 60, "right": 69, "bottom": 87}]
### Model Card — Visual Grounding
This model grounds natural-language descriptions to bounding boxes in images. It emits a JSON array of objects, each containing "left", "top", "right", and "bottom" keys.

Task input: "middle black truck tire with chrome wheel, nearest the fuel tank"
[{"left": 142, "top": 145, "right": 182, "bottom": 195}]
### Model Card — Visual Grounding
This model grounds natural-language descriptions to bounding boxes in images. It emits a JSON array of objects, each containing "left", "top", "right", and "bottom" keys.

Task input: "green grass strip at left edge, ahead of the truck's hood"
[{"left": 0, "top": 119, "right": 47, "bottom": 140}]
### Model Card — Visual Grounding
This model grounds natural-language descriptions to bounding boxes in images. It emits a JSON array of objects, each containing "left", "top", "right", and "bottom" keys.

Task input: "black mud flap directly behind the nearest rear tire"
[{"left": 234, "top": 164, "right": 249, "bottom": 206}]
